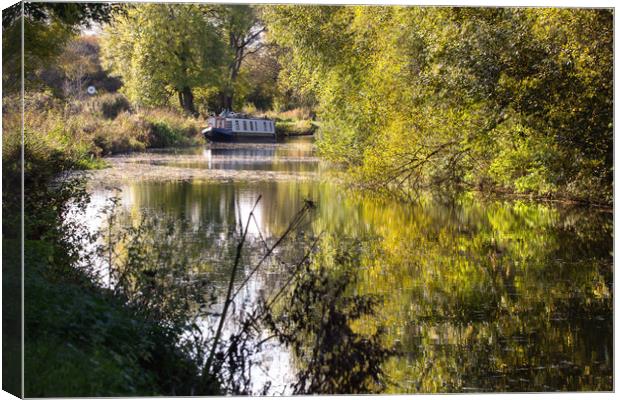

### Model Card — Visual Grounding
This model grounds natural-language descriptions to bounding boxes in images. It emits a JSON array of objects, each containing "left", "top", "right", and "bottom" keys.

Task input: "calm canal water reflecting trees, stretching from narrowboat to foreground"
[{"left": 85, "top": 139, "right": 613, "bottom": 394}]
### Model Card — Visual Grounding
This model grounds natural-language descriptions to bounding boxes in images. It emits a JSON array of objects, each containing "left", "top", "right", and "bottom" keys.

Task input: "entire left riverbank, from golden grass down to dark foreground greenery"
[{"left": 2, "top": 93, "right": 219, "bottom": 397}]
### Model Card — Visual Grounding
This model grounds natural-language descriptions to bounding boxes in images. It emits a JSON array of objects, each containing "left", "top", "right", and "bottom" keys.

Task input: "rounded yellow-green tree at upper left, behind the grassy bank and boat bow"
[{"left": 102, "top": 4, "right": 225, "bottom": 115}]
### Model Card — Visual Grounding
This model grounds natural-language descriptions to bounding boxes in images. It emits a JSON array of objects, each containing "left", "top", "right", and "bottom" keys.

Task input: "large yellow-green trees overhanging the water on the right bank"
[{"left": 264, "top": 6, "right": 613, "bottom": 204}]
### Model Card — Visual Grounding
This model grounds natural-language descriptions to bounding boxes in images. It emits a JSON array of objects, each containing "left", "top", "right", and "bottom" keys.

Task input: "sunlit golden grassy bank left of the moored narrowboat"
[{"left": 18, "top": 93, "right": 204, "bottom": 162}]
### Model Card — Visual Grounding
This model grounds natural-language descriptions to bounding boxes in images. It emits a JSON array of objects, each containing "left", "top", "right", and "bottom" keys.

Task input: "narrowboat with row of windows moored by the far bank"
[{"left": 202, "top": 111, "right": 276, "bottom": 142}]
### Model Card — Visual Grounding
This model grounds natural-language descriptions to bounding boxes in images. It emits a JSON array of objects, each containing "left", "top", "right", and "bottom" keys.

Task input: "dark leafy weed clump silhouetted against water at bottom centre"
[{"left": 266, "top": 240, "right": 395, "bottom": 394}]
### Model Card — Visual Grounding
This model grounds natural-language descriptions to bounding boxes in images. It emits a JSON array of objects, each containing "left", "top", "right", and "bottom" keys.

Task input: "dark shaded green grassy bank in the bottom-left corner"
[{"left": 22, "top": 241, "right": 218, "bottom": 397}]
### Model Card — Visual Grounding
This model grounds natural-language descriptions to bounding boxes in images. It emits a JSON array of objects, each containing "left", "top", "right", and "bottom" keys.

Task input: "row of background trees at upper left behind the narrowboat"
[{"left": 3, "top": 3, "right": 302, "bottom": 115}]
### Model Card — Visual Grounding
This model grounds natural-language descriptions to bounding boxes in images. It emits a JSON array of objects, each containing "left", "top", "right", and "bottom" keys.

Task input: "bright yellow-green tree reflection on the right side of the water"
[{"left": 340, "top": 197, "right": 612, "bottom": 392}]
